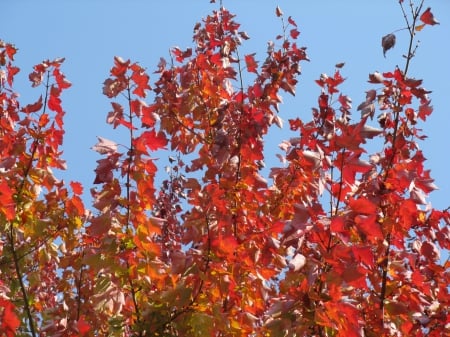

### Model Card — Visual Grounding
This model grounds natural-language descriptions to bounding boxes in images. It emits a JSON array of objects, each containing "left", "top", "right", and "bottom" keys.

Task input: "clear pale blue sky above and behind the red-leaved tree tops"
[{"left": 0, "top": 0, "right": 450, "bottom": 208}]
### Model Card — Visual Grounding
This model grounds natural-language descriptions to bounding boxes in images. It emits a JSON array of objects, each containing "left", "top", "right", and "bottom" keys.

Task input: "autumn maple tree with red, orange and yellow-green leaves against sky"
[{"left": 0, "top": 0, "right": 450, "bottom": 337}]
